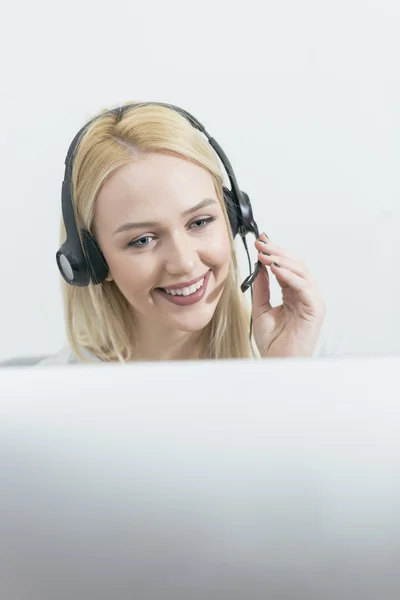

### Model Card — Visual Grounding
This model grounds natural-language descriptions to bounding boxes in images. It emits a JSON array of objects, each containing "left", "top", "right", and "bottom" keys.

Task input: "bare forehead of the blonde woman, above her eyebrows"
[{"left": 95, "top": 153, "right": 217, "bottom": 226}]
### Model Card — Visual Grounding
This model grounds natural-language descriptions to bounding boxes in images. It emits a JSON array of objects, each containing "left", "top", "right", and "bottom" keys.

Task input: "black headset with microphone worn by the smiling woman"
[{"left": 56, "top": 102, "right": 261, "bottom": 292}]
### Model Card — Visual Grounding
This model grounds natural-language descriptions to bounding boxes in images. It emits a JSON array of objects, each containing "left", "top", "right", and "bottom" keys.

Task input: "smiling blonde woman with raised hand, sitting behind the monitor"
[{"left": 41, "top": 103, "right": 332, "bottom": 364}]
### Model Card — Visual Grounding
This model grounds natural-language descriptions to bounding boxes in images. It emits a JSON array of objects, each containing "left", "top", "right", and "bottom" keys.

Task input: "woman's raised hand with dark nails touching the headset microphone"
[{"left": 252, "top": 234, "right": 326, "bottom": 358}]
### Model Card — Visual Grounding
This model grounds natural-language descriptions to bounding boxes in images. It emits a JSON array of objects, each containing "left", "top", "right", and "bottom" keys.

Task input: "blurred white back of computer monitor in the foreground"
[{"left": 0, "top": 357, "right": 400, "bottom": 600}]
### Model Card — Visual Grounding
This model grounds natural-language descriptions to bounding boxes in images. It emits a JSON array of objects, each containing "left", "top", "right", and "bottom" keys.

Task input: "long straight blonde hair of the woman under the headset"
[{"left": 60, "top": 104, "right": 252, "bottom": 362}]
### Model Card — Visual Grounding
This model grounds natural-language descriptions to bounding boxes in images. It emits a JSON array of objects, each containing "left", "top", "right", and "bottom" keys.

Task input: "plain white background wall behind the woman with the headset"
[{"left": 0, "top": 0, "right": 400, "bottom": 359}]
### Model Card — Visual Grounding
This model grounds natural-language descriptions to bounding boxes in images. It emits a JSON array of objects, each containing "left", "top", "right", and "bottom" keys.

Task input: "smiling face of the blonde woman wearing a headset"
[{"left": 94, "top": 153, "right": 231, "bottom": 332}]
